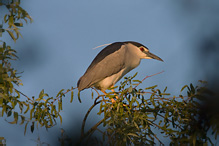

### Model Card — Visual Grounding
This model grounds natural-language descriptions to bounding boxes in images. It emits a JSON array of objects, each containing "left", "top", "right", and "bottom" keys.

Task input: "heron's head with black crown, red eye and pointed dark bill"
[{"left": 125, "top": 41, "right": 163, "bottom": 61}]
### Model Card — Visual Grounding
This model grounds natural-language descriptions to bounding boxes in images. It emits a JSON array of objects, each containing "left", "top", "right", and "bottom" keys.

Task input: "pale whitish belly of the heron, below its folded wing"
[{"left": 94, "top": 68, "right": 126, "bottom": 90}]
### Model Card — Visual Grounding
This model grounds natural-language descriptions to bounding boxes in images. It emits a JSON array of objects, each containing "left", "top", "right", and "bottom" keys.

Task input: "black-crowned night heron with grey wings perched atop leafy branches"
[{"left": 77, "top": 41, "right": 163, "bottom": 98}]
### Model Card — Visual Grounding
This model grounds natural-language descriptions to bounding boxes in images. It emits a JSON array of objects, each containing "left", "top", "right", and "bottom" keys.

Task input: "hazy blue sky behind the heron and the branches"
[{"left": 0, "top": 0, "right": 219, "bottom": 146}]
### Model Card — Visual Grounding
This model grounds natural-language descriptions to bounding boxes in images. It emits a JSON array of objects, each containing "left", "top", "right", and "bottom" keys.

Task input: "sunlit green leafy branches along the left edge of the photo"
[{"left": 0, "top": 0, "right": 70, "bottom": 133}]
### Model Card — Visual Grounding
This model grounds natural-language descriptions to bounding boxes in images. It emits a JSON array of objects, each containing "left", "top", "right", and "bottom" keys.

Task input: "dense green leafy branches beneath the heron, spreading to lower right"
[{"left": 78, "top": 73, "right": 219, "bottom": 145}]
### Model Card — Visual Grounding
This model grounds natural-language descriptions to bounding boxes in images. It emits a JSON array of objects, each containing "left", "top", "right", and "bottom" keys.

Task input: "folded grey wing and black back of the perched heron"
[{"left": 78, "top": 42, "right": 125, "bottom": 91}]
